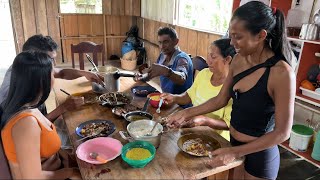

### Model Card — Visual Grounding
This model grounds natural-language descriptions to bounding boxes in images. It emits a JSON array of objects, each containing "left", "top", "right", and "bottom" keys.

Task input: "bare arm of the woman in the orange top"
[{"left": 12, "top": 116, "right": 75, "bottom": 179}]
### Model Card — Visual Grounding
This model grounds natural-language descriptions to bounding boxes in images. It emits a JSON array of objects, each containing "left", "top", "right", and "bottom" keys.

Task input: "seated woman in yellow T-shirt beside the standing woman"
[{"left": 161, "top": 39, "right": 236, "bottom": 140}]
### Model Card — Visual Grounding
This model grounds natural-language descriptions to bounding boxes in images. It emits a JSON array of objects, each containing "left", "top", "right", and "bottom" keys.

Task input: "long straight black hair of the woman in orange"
[{"left": 0, "top": 51, "right": 52, "bottom": 129}]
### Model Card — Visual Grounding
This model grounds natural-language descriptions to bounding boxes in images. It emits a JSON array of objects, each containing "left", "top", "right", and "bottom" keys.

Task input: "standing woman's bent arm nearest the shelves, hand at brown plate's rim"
[{"left": 213, "top": 63, "right": 296, "bottom": 164}]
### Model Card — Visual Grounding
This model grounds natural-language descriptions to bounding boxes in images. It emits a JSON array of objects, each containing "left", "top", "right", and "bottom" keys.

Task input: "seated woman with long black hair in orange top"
[{"left": 0, "top": 51, "right": 81, "bottom": 179}]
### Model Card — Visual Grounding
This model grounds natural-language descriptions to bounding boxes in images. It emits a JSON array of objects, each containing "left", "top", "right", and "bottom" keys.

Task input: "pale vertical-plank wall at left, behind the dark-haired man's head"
[{"left": 9, "top": 0, "right": 61, "bottom": 61}]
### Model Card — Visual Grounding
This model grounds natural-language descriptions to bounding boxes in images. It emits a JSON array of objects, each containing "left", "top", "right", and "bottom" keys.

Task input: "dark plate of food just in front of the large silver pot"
[{"left": 99, "top": 92, "right": 133, "bottom": 106}]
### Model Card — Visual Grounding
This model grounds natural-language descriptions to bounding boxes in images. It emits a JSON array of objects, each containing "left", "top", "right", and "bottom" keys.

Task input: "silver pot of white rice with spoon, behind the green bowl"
[{"left": 119, "top": 120, "right": 163, "bottom": 148}]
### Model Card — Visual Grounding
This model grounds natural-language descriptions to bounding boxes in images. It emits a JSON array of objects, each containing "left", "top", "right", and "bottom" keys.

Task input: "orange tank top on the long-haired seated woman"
[{"left": 1, "top": 113, "right": 61, "bottom": 163}]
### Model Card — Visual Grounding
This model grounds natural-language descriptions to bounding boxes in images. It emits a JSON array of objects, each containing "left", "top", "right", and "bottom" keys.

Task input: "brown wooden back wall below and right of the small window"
[{"left": 60, "top": 0, "right": 140, "bottom": 64}]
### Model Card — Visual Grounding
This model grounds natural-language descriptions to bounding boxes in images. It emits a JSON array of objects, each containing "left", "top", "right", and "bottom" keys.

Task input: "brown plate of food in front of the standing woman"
[{"left": 178, "top": 133, "right": 221, "bottom": 156}]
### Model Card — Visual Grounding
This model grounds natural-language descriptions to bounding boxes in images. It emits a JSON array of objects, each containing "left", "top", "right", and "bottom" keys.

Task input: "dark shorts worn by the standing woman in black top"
[{"left": 230, "top": 136, "right": 280, "bottom": 179}]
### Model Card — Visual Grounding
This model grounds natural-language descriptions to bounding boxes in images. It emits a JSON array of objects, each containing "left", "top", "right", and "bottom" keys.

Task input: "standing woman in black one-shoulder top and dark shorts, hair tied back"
[{"left": 167, "top": 1, "right": 296, "bottom": 179}]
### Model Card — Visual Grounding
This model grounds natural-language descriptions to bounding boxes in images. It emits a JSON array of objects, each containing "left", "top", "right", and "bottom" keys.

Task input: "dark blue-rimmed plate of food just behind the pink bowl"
[{"left": 76, "top": 119, "right": 116, "bottom": 138}]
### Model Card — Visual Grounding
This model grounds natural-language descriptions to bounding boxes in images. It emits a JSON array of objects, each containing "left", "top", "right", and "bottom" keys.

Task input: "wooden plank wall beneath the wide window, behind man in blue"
[{"left": 137, "top": 18, "right": 221, "bottom": 63}]
